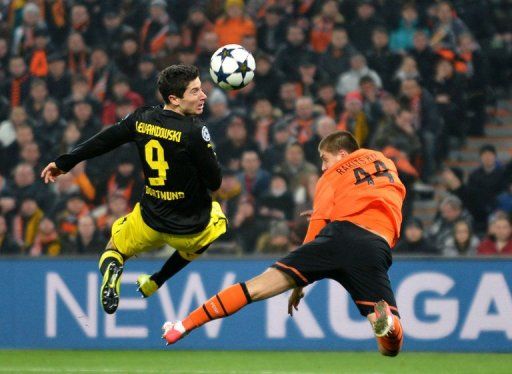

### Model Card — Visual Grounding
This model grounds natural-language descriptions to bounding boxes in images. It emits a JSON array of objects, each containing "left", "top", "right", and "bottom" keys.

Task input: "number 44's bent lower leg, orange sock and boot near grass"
[{"left": 372, "top": 300, "right": 403, "bottom": 356}]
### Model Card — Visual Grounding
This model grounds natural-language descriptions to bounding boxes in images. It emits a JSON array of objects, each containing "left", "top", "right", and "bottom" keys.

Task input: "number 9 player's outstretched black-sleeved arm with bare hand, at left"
[{"left": 41, "top": 115, "right": 133, "bottom": 183}]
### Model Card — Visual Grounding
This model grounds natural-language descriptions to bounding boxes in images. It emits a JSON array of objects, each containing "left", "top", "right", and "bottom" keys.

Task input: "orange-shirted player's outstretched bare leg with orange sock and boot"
[{"left": 162, "top": 268, "right": 296, "bottom": 345}]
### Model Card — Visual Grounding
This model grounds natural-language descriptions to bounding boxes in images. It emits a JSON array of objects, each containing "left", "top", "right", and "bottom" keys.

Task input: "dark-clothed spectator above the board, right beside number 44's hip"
[{"left": 393, "top": 217, "right": 440, "bottom": 255}]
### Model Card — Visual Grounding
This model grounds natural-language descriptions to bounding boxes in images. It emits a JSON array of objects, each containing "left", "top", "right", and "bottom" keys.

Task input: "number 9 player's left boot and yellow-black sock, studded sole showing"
[{"left": 99, "top": 243, "right": 124, "bottom": 314}]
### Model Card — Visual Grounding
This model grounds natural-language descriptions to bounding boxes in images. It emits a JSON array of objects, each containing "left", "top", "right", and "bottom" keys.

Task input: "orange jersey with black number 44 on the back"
[{"left": 311, "top": 148, "right": 405, "bottom": 247}]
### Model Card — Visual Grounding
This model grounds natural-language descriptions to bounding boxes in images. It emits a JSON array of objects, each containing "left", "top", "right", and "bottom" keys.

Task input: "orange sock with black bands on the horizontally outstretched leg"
[{"left": 182, "top": 282, "right": 252, "bottom": 331}]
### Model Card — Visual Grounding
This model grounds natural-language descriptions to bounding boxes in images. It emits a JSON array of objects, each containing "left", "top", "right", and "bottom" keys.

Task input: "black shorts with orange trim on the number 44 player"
[{"left": 272, "top": 221, "right": 398, "bottom": 316}]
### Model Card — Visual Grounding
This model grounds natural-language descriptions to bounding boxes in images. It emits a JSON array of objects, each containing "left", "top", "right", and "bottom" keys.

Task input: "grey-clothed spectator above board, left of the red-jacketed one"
[{"left": 441, "top": 219, "right": 480, "bottom": 257}]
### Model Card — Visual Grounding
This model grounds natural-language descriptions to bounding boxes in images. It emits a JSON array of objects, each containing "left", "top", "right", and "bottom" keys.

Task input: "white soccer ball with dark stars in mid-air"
[{"left": 210, "top": 44, "right": 256, "bottom": 90}]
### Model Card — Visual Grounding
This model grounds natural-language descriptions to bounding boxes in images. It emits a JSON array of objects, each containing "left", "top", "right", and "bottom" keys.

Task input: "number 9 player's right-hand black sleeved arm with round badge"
[{"left": 189, "top": 126, "right": 222, "bottom": 191}]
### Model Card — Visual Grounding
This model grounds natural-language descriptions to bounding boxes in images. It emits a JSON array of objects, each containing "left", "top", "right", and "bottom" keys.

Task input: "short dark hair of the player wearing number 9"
[{"left": 157, "top": 65, "right": 199, "bottom": 104}]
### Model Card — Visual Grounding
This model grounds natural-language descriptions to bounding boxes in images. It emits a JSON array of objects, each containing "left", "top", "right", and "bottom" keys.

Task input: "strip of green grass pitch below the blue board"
[{"left": 0, "top": 348, "right": 512, "bottom": 374}]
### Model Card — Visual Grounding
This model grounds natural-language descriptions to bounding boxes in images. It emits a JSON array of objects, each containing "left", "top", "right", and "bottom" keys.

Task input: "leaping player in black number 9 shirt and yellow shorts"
[{"left": 41, "top": 65, "right": 226, "bottom": 314}]
